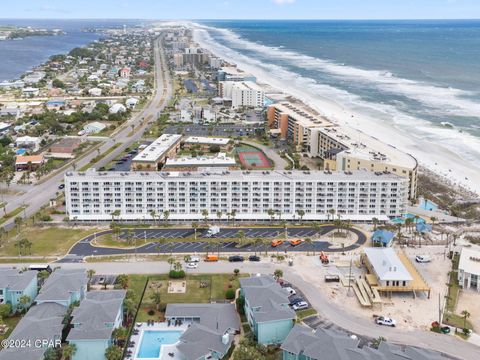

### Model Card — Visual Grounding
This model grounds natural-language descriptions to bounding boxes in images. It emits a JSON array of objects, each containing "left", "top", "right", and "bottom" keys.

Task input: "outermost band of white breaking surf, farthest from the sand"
[{"left": 196, "top": 24, "right": 480, "bottom": 117}]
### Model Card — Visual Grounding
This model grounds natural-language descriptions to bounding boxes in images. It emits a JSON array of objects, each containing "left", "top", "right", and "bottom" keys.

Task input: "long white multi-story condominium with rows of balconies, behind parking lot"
[{"left": 65, "top": 169, "right": 408, "bottom": 221}]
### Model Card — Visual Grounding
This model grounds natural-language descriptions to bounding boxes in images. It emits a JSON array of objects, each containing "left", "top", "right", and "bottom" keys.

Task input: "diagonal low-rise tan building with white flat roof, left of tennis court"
[{"left": 131, "top": 134, "right": 182, "bottom": 171}]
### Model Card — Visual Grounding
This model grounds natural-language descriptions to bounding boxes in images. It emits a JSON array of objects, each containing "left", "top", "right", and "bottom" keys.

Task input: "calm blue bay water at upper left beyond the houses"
[{"left": 0, "top": 19, "right": 139, "bottom": 81}]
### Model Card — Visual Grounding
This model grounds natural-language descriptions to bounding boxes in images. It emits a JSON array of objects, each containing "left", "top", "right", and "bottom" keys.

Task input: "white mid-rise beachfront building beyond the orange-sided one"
[{"left": 219, "top": 81, "right": 265, "bottom": 108}]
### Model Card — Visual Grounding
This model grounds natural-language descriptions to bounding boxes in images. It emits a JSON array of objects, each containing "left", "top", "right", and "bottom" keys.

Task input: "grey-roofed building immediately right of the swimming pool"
[{"left": 165, "top": 304, "right": 240, "bottom": 360}]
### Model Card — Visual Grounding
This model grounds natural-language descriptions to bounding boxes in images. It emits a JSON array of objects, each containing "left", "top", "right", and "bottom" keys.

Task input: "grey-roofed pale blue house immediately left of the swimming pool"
[{"left": 67, "top": 290, "right": 126, "bottom": 360}]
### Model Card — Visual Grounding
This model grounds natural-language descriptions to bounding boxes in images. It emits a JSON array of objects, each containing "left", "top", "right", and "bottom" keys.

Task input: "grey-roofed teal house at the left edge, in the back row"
[{"left": 0, "top": 269, "right": 38, "bottom": 312}]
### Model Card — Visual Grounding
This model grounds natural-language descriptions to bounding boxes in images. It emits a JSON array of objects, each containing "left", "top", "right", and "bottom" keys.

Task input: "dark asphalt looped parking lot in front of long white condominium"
[{"left": 58, "top": 226, "right": 367, "bottom": 263}]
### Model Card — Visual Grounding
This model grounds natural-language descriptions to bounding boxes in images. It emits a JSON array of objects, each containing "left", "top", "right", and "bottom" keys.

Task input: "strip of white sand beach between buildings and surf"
[{"left": 192, "top": 26, "right": 480, "bottom": 197}]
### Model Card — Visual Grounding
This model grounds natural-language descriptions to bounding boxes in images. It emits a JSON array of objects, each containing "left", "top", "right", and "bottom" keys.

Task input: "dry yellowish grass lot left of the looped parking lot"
[{"left": 0, "top": 227, "right": 93, "bottom": 256}]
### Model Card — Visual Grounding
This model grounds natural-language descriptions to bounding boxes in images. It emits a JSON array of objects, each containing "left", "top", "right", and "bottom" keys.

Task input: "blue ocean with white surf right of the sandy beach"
[{"left": 194, "top": 20, "right": 480, "bottom": 191}]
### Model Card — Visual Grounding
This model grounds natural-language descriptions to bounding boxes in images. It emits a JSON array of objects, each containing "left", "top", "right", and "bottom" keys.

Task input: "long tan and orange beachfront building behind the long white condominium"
[{"left": 267, "top": 102, "right": 418, "bottom": 199}]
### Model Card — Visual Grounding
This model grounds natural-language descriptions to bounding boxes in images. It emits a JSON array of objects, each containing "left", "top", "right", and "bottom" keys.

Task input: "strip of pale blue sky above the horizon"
[{"left": 0, "top": 0, "right": 480, "bottom": 19}]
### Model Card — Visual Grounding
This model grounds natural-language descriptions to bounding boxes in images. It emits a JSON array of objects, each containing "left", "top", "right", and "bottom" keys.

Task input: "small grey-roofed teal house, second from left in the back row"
[{"left": 36, "top": 269, "right": 88, "bottom": 307}]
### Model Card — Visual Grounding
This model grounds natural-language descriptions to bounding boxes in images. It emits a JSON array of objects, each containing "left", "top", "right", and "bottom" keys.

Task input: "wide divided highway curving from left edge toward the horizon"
[{"left": 1, "top": 37, "right": 173, "bottom": 230}]
